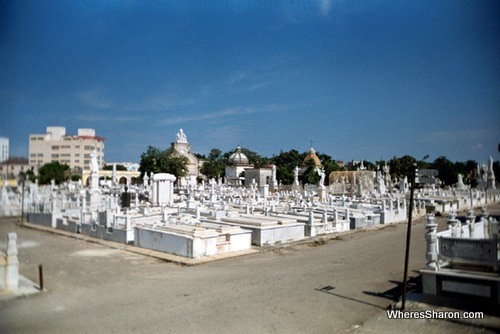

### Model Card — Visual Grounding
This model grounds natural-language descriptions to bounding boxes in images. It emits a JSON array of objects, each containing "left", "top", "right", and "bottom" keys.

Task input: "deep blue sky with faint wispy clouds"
[{"left": 0, "top": 0, "right": 500, "bottom": 162}]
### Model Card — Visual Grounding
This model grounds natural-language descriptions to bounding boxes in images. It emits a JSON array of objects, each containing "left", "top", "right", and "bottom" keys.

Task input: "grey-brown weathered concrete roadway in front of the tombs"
[{"left": 0, "top": 206, "right": 500, "bottom": 333}]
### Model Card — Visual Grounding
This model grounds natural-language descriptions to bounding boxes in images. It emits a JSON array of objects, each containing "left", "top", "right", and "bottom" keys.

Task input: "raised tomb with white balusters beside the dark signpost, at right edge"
[{"left": 420, "top": 210, "right": 500, "bottom": 310}]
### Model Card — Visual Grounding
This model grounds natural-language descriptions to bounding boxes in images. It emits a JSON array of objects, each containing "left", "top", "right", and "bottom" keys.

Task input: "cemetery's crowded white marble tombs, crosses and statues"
[{"left": 0, "top": 132, "right": 500, "bottom": 303}]
